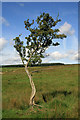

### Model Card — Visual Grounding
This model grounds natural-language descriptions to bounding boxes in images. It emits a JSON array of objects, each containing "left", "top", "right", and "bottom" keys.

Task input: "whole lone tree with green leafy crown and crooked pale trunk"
[{"left": 13, "top": 13, "right": 66, "bottom": 106}]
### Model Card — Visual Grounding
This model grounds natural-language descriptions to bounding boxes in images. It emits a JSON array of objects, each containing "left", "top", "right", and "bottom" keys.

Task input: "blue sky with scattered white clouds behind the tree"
[{"left": 0, "top": 2, "right": 78, "bottom": 65}]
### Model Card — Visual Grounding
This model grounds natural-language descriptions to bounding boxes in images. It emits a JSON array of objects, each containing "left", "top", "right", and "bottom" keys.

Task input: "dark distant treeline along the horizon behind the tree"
[{"left": 0, "top": 63, "right": 64, "bottom": 67}]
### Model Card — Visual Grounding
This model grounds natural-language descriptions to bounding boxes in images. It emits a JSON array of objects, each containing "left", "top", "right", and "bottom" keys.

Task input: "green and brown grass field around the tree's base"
[{"left": 2, "top": 65, "right": 78, "bottom": 118}]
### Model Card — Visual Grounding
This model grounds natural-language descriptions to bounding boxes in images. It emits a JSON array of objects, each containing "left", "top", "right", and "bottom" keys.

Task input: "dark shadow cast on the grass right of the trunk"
[{"left": 42, "top": 91, "right": 72, "bottom": 102}]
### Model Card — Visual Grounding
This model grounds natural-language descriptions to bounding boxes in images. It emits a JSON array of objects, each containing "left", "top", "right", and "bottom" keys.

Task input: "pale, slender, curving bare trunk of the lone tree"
[{"left": 25, "top": 65, "right": 36, "bottom": 106}]
